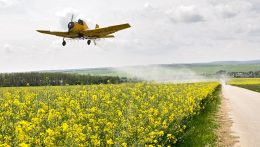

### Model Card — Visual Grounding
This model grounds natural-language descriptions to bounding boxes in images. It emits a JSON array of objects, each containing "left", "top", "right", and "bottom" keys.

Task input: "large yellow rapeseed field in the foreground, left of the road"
[{"left": 0, "top": 82, "right": 219, "bottom": 146}]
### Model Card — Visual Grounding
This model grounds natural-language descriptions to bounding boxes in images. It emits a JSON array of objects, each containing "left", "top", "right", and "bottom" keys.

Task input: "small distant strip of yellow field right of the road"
[{"left": 228, "top": 78, "right": 260, "bottom": 85}]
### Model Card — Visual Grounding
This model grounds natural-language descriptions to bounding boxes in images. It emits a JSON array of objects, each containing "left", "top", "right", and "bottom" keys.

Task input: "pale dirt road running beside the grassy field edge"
[{"left": 222, "top": 84, "right": 260, "bottom": 147}]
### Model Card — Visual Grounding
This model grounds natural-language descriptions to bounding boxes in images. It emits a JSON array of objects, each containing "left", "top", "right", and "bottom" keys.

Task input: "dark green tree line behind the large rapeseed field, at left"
[{"left": 0, "top": 72, "right": 123, "bottom": 87}]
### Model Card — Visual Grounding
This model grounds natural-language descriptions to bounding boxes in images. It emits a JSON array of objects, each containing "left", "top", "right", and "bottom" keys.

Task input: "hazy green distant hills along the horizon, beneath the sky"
[{"left": 45, "top": 60, "right": 260, "bottom": 77}]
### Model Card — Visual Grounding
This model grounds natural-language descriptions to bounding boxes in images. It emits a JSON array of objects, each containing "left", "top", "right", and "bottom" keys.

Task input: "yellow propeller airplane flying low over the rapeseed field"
[{"left": 37, "top": 15, "right": 131, "bottom": 46}]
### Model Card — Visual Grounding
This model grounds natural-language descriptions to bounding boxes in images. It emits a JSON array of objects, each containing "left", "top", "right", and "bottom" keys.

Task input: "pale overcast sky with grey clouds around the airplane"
[{"left": 0, "top": 0, "right": 260, "bottom": 72}]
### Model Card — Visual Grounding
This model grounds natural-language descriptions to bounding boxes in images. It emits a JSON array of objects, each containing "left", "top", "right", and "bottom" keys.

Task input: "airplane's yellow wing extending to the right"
[{"left": 82, "top": 24, "right": 131, "bottom": 38}]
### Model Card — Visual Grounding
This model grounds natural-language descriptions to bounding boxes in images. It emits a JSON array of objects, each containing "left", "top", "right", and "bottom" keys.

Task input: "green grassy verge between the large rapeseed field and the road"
[{"left": 176, "top": 86, "right": 220, "bottom": 147}]
